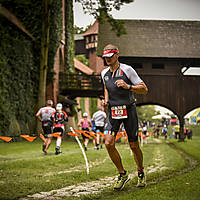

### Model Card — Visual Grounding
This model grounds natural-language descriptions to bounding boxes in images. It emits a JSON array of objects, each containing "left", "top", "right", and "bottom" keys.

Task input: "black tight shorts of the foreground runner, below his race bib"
[{"left": 104, "top": 104, "right": 138, "bottom": 142}]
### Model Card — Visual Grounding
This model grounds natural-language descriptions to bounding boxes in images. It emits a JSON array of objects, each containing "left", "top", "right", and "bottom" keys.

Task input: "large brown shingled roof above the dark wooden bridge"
[{"left": 97, "top": 20, "right": 200, "bottom": 58}]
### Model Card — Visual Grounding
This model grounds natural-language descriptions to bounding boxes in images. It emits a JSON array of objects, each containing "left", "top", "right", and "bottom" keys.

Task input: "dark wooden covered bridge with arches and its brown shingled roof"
[{"left": 97, "top": 20, "right": 200, "bottom": 139}]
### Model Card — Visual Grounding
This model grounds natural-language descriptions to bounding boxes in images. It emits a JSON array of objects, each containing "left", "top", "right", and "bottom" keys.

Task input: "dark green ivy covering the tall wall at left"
[{"left": 0, "top": 0, "right": 62, "bottom": 135}]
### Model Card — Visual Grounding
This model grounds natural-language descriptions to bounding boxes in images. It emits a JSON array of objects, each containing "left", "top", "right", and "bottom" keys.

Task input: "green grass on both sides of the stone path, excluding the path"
[{"left": 0, "top": 138, "right": 200, "bottom": 199}]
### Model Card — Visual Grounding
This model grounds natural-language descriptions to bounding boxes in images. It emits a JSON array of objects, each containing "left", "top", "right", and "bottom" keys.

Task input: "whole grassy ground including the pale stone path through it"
[{"left": 0, "top": 137, "right": 200, "bottom": 200}]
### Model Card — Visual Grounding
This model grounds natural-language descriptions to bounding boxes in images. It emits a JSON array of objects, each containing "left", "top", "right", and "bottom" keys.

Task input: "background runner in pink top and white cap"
[{"left": 78, "top": 112, "right": 92, "bottom": 151}]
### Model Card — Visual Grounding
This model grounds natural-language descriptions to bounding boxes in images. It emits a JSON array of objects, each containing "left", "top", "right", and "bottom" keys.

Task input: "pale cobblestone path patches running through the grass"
[{"left": 21, "top": 140, "right": 167, "bottom": 200}]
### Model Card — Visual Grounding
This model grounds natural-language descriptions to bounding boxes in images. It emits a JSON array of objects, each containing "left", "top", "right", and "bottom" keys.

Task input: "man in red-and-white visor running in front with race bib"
[{"left": 101, "top": 44, "right": 148, "bottom": 190}]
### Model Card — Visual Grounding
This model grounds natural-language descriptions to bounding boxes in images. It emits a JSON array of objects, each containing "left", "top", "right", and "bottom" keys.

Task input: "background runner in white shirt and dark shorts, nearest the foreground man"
[{"left": 92, "top": 106, "right": 106, "bottom": 150}]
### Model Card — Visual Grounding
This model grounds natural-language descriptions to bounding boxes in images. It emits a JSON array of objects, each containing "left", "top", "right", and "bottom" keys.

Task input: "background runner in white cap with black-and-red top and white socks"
[{"left": 51, "top": 103, "right": 68, "bottom": 155}]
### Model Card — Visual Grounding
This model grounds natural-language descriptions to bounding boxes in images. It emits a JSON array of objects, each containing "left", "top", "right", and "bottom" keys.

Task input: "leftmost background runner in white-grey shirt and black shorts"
[{"left": 36, "top": 100, "right": 55, "bottom": 154}]
